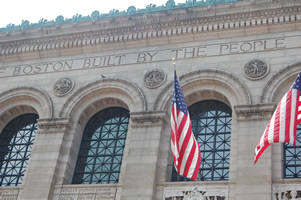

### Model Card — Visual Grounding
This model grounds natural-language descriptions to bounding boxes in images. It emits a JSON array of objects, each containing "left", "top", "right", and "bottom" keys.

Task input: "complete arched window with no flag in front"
[{"left": 72, "top": 107, "right": 129, "bottom": 184}]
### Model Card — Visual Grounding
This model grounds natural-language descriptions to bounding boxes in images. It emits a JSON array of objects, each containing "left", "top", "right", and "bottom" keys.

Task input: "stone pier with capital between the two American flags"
[{"left": 231, "top": 104, "right": 275, "bottom": 200}]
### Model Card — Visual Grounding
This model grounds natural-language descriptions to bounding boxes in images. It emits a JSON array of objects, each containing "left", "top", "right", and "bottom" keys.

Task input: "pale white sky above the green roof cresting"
[{"left": 0, "top": 0, "right": 186, "bottom": 28}]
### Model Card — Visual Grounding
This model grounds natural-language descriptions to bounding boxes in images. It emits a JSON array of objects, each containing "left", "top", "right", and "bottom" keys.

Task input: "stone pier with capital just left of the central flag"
[{"left": 121, "top": 111, "right": 167, "bottom": 200}]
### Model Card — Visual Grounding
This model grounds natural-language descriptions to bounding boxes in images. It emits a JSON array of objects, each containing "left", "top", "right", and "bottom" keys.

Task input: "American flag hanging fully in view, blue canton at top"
[{"left": 171, "top": 71, "right": 201, "bottom": 180}]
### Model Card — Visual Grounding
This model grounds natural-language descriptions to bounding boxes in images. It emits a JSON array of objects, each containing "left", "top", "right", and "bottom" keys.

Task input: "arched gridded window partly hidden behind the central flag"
[{"left": 172, "top": 100, "right": 232, "bottom": 181}]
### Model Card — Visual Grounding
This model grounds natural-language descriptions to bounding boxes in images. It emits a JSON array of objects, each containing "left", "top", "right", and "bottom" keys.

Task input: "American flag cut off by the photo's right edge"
[{"left": 254, "top": 72, "right": 301, "bottom": 164}]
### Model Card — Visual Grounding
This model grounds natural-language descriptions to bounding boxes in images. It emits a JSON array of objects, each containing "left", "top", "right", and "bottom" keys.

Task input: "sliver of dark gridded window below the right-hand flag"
[{"left": 283, "top": 124, "right": 301, "bottom": 178}]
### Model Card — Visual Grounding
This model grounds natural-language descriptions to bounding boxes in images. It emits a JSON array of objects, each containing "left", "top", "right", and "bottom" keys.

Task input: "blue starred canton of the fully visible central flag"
[{"left": 172, "top": 71, "right": 188, "bottom": 115}]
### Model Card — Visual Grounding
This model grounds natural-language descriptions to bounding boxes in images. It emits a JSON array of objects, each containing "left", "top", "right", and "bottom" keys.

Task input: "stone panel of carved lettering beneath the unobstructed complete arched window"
[{"left": 59, "top": 188, "right": 116, "bottom": 200}]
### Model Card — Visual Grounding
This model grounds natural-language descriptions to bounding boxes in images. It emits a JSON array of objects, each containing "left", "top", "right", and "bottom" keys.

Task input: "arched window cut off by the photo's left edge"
[{"left": 0, "top": 114, "right": 38, "bottom": 186}]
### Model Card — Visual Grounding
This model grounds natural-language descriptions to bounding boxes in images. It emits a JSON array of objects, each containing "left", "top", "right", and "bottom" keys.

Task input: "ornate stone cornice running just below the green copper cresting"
[{"left": 0, "top": 2, "right": 301, "bottom": 57}]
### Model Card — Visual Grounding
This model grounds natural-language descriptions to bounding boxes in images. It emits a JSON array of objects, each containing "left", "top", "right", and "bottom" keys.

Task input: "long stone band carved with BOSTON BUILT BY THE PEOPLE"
[{"left": 0, "top": 36, "right": 288, "bottom": 78}]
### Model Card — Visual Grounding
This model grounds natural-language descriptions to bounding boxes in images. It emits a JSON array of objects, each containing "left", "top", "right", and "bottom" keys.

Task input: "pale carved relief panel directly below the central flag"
[{"left": 163, "top": 186, "right": 228, "bottom": 200}]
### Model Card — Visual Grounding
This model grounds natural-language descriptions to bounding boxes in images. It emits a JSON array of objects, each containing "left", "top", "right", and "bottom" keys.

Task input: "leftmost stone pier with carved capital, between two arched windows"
[{"left": 18, "top": 118, "right": 70, "bottom": 200}]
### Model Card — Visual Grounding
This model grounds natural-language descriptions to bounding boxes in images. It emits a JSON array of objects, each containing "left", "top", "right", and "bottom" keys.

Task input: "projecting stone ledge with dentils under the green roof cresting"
[{"left": 0, "top": 3, "right": 301, "bottom": 56}]
